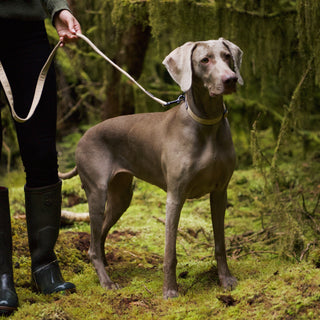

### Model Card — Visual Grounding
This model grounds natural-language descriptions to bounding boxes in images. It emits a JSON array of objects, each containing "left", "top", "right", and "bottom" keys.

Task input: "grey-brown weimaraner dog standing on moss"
[{"left": 60, "top": 38, "right": 243, "bottom": 298}]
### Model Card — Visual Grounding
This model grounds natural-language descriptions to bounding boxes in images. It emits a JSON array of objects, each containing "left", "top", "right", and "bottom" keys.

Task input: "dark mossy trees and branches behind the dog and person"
[{"left": 1, "top": 0, "right": 320, "bottom": 170}]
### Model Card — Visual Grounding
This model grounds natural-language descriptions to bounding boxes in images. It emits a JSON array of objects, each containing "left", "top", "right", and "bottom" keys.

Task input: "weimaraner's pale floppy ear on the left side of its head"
[{"left": 162, "top": 42, "right": 196, "bottom": 92}]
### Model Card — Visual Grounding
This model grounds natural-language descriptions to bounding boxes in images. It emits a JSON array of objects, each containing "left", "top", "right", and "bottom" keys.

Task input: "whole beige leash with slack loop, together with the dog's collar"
[{"left": 0, "top": 33, "right": 228, "bottom": 125}]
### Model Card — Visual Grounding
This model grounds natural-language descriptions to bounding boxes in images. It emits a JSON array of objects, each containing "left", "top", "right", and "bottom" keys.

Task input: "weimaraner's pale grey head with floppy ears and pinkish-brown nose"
[{"left": 163, "top": 38, "right": 243, "bottom": 97}]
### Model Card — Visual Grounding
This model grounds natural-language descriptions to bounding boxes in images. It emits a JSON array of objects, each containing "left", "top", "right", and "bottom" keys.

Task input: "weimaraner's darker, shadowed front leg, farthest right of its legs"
[{"left": 210, "top": 190, "right": 237, "bottom": 290}]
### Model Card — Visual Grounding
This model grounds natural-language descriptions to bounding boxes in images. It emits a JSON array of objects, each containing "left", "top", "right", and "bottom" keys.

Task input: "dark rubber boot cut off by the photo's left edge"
[{"left": 0, "top": 187, "right": 18, "bottom": 316}]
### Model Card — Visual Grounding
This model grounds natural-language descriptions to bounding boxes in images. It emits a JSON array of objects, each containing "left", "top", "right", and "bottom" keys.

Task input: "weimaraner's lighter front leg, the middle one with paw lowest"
[{"left": 163, "top": 193, "right": 183, "bottom": 299}]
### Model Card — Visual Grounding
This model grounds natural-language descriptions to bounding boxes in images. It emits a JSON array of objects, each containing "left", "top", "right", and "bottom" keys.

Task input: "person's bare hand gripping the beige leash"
[{"left": 53, "top": 10, "right": 81, "bottom": 46}]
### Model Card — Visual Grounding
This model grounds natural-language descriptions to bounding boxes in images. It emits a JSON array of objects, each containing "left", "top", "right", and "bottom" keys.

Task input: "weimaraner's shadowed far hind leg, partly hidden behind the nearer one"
[{"left": 100, "top": 172, "right": 133, "bottom": 265}]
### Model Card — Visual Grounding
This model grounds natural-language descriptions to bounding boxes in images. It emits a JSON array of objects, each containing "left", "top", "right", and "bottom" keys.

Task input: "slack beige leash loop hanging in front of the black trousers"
[{"left": 0, "top": 41, "right": 61, "bottom": 123}]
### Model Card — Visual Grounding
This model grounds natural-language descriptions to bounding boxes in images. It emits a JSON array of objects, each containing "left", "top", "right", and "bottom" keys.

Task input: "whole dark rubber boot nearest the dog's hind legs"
[{"left": 25, "top": 181, "right": 75, "bottom": 294}]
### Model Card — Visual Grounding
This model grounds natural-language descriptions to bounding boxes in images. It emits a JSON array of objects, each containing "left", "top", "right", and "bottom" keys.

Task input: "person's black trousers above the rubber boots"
[{"left": 0, "top": 19, "right": 59, "bottom": 188}]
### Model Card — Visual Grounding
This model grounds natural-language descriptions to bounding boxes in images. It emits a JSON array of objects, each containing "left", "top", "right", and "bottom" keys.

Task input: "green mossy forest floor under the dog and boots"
[{"left": 2, "top": 129, "right": 320, "bottom": 320}]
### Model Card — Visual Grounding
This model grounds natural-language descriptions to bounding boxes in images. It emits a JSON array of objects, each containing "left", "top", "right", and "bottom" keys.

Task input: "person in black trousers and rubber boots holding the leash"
[{"left": 0, "top": 0, "right": 81, "bottom": 315}]
